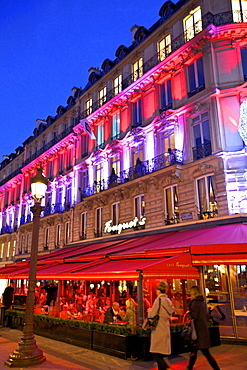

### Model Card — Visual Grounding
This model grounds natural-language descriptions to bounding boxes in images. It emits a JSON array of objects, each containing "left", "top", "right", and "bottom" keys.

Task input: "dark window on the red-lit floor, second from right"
[{"left": 188, "top": 58, "right": 205, "bottom": 98}]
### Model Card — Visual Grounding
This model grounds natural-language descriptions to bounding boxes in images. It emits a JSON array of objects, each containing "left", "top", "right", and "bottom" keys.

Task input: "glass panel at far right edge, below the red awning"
[{"left": 230, "top": 265, "right": 247, "bottom": 338}]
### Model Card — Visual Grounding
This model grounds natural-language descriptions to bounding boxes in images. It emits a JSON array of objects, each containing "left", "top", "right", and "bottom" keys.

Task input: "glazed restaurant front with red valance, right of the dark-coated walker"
[{"left": 190, "top": 243, "right": 247, "bottom": 340}]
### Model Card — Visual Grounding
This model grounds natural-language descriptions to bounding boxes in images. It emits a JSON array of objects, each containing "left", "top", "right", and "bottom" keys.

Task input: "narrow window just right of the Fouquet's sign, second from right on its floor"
[{"left": 164, "top": 185, "right": 179, "bottom": 225}]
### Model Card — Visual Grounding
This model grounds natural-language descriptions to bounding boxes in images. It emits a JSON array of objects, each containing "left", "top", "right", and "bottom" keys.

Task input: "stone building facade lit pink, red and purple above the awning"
[{"left": 0, "top": 0, "right": 247, "bottom": 294}]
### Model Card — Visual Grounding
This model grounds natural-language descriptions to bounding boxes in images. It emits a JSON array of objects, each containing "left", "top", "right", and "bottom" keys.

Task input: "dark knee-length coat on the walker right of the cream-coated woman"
[{"left": 189, "top": 295, "right": 211, "bottom": 349}]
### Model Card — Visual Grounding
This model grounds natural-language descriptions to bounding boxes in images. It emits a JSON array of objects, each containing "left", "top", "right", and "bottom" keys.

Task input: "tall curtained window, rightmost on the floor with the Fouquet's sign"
[{"left": 196, "top": 175, "right": 218, "bottom": 219}]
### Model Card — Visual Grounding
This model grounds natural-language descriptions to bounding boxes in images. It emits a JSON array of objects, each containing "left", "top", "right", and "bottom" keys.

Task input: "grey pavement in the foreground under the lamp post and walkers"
[{"left": 0, "top": 327, "right": 247, "bottom": 370}]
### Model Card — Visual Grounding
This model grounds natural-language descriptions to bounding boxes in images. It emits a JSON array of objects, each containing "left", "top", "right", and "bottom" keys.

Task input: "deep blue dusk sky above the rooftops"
[{"left": 0, "top": 0, "right": 176, "bottom": 161}]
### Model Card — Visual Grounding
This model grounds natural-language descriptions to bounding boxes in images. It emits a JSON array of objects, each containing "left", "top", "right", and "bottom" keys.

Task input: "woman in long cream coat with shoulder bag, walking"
[{"left": 148, "top": 281, "right": 175, "bottom": 370}]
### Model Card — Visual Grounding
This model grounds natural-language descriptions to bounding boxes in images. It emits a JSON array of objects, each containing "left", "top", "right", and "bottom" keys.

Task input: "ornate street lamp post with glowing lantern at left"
[{"left": 5, "top": 167, "right": 48, "bottom": 367}]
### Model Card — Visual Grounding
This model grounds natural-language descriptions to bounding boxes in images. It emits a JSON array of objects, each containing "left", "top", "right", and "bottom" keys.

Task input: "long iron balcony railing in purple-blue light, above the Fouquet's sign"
[{"left": 82, "top": 149, "right": 183, "bottom": 198}]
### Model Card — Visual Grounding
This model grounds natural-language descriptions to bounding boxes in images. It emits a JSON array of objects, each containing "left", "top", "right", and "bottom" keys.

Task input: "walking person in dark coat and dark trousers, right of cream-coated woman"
[{"left": 186, "top": 285, "right": 220, "bottom": 370}]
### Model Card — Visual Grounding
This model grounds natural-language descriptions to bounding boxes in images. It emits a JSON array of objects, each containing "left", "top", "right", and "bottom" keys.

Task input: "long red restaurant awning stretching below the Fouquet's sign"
[{"left": 0, "top": 224, "right": 247, "bottom": 280}]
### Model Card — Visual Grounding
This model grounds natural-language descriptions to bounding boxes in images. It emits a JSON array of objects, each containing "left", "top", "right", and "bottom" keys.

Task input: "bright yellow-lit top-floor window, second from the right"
[{"left": 184, "top": 6, "right": 202, "bottom": 42}]
